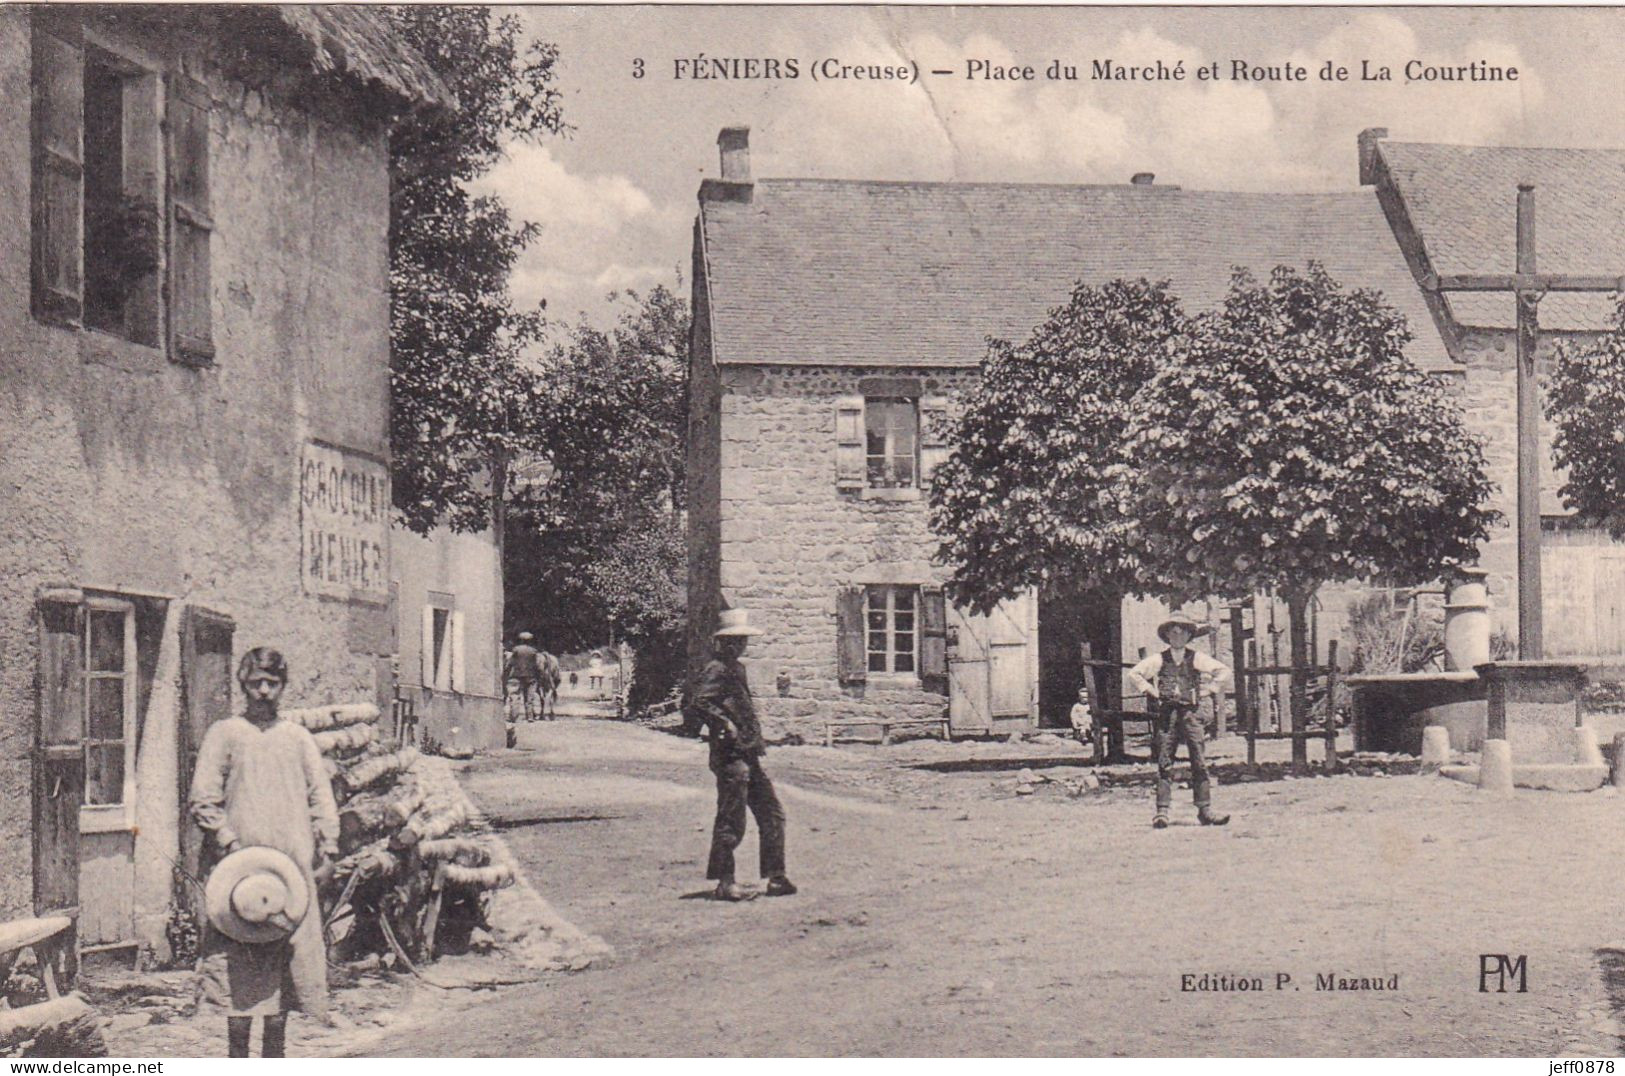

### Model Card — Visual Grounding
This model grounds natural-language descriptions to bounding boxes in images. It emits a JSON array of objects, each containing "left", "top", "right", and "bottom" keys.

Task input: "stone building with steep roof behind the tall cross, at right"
[{"left": 1360, "top": 128, "right": 1625, "bottom": 665}]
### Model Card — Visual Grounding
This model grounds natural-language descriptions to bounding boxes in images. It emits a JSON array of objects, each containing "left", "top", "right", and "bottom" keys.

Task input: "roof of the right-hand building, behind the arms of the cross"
[{"left": 1378, "top": 141, "right": 1625, "bottom": 330}]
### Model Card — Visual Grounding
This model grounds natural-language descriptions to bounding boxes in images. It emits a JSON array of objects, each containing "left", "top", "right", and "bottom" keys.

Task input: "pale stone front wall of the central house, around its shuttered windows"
[{"left": 720, "top": 366, "right": 977, "bottom": 736}]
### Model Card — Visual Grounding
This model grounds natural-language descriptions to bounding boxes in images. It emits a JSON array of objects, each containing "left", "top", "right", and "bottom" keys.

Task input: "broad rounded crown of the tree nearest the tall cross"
[{"left": 1110, "top": 263, "right": 1495, "bottom": 598}]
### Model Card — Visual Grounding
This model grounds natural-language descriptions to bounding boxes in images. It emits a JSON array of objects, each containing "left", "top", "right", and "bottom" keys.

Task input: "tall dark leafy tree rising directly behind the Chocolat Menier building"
[{"left": 385, "top": 5, "right": 566, "bottom": 543}]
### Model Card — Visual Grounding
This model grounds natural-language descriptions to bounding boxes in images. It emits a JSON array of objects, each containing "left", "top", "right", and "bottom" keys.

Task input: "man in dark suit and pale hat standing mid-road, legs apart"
[{"left": 689, "top": 610, "right": 796, "bottom": 900}]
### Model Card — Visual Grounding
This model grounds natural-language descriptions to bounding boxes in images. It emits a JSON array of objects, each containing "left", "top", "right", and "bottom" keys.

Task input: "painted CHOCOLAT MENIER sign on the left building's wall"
[{"left": 299, "top": 440, "right": 390, "bottom": 601}]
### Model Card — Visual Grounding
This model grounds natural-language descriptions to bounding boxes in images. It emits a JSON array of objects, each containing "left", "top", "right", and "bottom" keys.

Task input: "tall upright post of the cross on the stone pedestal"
[{"left": 1516, "top": 184, "right": 1545, "bottom": 662}]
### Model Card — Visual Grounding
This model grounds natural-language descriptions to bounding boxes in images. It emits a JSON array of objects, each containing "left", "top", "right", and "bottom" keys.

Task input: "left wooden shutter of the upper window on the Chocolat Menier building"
[{"left": 31, "top": 13, "right": 85, "bottom": 325}]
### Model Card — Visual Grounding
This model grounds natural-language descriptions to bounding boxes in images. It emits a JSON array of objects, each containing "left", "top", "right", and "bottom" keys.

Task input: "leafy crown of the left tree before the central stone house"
[{"left": 931, "top": 280, "right": 1194, "bottom": 613}]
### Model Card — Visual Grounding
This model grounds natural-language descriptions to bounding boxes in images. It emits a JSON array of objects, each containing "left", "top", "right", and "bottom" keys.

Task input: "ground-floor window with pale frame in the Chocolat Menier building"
[{"left": 83, "top": 598, "right": 137, "bottom": 829}]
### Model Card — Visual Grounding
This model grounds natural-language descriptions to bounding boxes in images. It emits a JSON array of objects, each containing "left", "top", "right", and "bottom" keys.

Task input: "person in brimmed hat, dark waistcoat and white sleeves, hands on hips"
[{"left": 1128, "top": 616, "right": 1230, "bottom": 829}]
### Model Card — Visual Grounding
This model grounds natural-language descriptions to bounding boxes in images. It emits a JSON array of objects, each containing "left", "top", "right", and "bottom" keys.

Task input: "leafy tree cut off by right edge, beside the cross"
[{"left": 1545, "top": 297, "right": 1625, "bottom": 540}]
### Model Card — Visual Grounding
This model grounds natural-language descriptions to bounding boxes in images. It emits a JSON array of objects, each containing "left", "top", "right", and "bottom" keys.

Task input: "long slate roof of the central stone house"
[{"left": 700, "top": 179, "right": 1450, "bottom": 367}]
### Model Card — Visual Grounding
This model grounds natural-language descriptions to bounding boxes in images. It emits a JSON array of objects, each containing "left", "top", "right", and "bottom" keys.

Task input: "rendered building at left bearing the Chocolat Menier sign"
[{"left": 0, "top": 5, "right": 453, "bottom": 968}]
